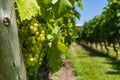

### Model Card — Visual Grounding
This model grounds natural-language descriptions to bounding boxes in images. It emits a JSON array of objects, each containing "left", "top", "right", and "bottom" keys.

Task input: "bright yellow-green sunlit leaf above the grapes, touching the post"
[{"left": 16, "top": 0, "right": 40, "bottom": 21}]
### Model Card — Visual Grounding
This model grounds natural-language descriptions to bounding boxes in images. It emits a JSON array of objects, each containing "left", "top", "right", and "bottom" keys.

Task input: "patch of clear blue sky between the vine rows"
[{"left": 75, "top": 0, "right": 107, "bottom": 24}]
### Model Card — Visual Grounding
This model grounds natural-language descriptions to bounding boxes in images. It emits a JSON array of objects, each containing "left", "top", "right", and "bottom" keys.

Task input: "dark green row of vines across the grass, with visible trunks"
[{"left": 78, "top": 0, "right": 120, "bottom": 58}]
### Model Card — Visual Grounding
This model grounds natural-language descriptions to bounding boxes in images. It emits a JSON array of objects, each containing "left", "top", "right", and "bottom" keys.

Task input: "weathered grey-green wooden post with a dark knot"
[{"left": 0, "top": 0, "right": 27, "bottom": 80}]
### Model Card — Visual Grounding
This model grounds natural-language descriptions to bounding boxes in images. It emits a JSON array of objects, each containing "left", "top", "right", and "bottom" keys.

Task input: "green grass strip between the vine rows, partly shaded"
[{"left": 70, "top": 43, "right": 120, "bottom": 80}]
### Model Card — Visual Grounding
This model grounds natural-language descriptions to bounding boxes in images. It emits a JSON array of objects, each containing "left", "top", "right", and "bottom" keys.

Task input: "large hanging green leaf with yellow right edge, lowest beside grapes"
[{"left": 47, "top": 37, "right": 67, "bottom": 70}]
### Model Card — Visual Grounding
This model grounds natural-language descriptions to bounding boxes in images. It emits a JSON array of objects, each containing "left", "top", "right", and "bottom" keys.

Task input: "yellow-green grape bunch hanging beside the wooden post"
[{"left": 19, "top": 22, "right": 46, "bottom": 68}]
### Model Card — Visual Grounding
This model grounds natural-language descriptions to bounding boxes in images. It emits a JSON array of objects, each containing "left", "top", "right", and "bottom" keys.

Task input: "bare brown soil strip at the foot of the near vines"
[{"left": 50, "top": 59, "right": 76, "bottom": 80}]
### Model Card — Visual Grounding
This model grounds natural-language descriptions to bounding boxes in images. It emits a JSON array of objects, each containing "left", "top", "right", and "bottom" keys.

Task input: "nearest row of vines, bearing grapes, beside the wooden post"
[{"left": 14, "top": 0, "right": 82, "bottom": 80}]
